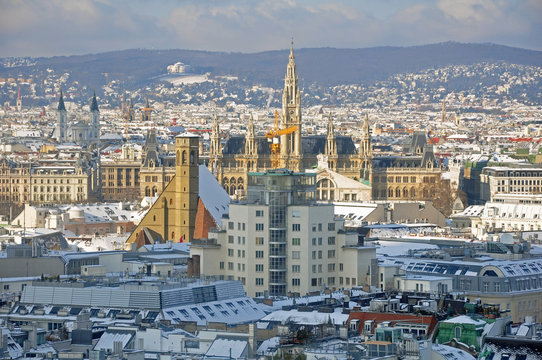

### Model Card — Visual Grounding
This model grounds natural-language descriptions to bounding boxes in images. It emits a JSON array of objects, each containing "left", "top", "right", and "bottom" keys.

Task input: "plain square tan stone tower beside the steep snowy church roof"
[{"left": 174, "top": 133, "right": 199, "bottom": 241}]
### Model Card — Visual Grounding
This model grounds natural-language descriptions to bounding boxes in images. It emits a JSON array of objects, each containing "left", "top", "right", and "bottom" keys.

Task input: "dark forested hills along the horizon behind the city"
[{"left": 0, "top": 42, "right": 542, "bottom": 88}]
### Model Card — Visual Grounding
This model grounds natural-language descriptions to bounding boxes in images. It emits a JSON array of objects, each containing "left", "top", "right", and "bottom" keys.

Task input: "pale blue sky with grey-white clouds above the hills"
[{"left": 0, "top": 0, "right": 542, "bottom": 57}]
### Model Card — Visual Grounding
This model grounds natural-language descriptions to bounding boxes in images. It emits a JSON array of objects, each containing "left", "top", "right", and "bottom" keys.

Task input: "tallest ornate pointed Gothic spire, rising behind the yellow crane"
[{"left": 280, "top": 41, "right": 302, "bottom": 171}]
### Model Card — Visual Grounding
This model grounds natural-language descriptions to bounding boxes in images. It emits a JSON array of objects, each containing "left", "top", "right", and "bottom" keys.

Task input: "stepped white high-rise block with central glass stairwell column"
[{"left": 190, "top": 170, "right": 376, "bottom": 297}]
